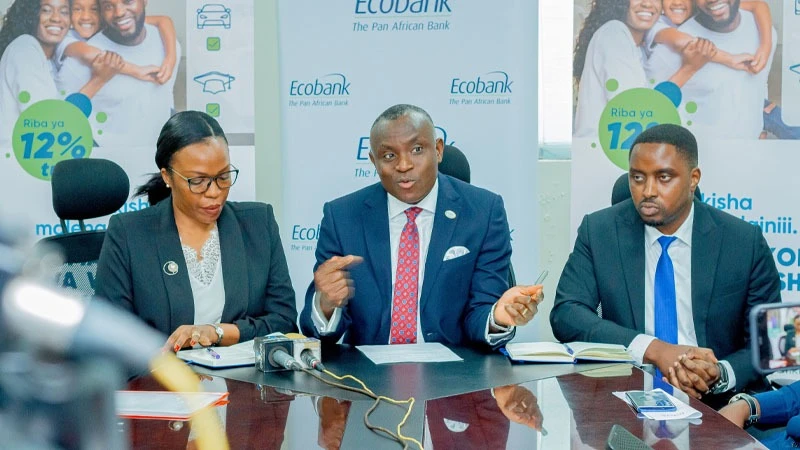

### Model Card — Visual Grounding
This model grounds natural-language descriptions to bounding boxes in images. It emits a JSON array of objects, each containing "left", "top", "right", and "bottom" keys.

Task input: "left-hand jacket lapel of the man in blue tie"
[{"left": 617, "top": 203, "right": 645, "bottom": 332}]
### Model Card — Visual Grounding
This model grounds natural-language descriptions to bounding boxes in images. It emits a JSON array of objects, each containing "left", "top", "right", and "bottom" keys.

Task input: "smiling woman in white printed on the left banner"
[{"left": 0, "top": 0, "right": 123, "bottom": 142}]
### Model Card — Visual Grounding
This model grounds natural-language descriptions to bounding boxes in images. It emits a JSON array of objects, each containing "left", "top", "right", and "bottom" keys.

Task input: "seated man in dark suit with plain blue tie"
[{"left": 550, "top": 124, "right": 780, "bottom": 398}]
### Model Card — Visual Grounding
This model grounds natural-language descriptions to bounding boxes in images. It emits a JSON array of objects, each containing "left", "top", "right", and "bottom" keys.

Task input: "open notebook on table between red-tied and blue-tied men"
[{"left": 506, "top": 342, "right": 634, "bottom": 363}]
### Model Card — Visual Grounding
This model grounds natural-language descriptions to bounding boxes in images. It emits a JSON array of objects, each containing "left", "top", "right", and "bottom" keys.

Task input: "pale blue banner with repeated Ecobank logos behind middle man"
[{"left": 278, "top": 0, "right": 539, "bottom": 339}]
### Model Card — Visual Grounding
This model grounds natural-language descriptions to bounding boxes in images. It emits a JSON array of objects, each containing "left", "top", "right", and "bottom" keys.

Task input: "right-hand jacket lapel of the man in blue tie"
[{"left": 692, "top": 201, "right": 722, "bottom": 347}]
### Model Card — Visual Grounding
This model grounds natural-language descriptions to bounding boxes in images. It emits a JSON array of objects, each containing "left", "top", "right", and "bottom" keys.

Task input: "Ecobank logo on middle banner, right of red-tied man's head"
[{"left": 449, "top": 70, "right": 514, "bottom": 105}]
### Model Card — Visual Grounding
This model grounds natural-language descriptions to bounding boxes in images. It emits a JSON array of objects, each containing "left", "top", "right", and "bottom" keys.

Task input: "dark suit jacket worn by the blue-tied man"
[{"left": 550, "top": 199, "right": 781, "bottom": 390}]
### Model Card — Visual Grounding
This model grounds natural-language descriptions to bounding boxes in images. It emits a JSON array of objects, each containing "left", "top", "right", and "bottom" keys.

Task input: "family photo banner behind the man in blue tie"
[{"left": 571, "top": 0, "right": 800, "bottom": 300}]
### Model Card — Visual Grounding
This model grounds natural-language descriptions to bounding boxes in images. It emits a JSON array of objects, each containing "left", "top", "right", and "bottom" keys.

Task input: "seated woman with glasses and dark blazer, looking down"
[{"left": 96, "top": 111, "right": 297, "bottom": 351}]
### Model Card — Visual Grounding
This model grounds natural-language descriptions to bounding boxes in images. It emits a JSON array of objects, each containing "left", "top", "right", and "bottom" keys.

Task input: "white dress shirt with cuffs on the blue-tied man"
[{"left": 628, "top": 204, "right": 736, "bottom": 386}]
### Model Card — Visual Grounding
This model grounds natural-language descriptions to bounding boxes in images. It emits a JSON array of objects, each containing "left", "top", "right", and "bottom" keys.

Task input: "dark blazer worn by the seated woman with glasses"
[{"left": 95, "top": 198, "right": 297, "bottom": 341}]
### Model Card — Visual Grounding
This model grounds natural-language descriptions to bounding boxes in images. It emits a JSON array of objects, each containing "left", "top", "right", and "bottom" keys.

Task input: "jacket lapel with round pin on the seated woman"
[{"left": 155, "top": 202, "right": 194, "bottom": 329}]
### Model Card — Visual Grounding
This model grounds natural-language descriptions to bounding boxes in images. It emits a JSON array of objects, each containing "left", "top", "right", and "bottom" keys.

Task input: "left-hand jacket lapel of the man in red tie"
[{"left": 362, "top": 185, "right": 392, "bottom": 316}]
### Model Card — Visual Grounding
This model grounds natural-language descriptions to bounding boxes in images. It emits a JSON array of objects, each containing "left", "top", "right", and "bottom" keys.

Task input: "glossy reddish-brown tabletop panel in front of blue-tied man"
[{"left": 425, "top": 365, "right": 763, "bottom": 450}]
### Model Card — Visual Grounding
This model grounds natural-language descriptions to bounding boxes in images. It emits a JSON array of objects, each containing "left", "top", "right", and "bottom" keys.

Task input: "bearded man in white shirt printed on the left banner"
[{"left": 58, "top": 0, "right": 180, "bottom": 147}]
